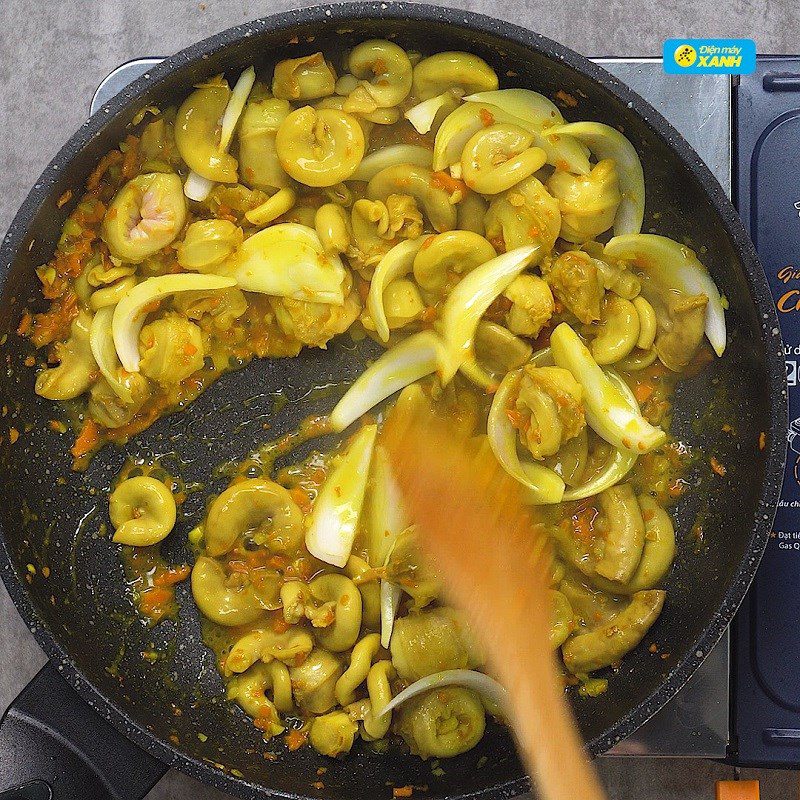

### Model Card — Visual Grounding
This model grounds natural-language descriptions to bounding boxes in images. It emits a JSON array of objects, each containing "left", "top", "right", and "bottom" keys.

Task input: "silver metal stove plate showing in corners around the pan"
[{"left": 91, "top": 57, "right": 732, "bottom": 758}]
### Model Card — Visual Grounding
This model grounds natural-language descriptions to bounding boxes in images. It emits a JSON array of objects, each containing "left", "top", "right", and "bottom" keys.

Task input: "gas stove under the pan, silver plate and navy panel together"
[{"left": 91, "top": 57, "right": 800, "bottom": 767}]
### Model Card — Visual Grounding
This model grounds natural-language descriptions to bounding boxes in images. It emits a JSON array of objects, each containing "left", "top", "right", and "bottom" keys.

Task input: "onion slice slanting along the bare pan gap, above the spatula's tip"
[{"left": 330, "top": 331, "right": 448, "bottom": 431}]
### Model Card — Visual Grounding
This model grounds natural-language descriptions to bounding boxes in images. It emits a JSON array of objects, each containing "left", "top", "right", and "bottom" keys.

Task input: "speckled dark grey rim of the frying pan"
[{"left": 0, "top": 0, "right": 788, "bottom": 800}]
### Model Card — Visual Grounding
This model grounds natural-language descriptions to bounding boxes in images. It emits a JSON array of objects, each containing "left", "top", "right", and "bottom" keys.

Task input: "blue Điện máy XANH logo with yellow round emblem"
[{"left": 663, "top": 39, "right": 756, "bottom": 75}]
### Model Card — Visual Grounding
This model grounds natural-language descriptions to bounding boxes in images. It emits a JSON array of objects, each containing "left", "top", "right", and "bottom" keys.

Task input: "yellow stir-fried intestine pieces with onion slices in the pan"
[{"left": 20, "top": 40, "right": 726, "bottom": 758}]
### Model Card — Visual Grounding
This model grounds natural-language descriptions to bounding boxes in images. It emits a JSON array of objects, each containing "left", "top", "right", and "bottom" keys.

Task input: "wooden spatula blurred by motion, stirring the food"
[{"left": 384, "top": 406, "right": 605, "bottom": 800}]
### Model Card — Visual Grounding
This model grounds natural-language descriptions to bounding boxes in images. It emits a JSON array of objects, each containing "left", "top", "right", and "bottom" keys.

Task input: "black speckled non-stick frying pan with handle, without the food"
[{"left": 0, "top": 2, "right": 786, "bottom": 800}]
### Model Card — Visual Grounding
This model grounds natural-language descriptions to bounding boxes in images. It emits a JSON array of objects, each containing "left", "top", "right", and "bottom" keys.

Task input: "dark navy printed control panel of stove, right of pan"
[{"left": 730, "top": 56, "right": 800, "bottom": 766}]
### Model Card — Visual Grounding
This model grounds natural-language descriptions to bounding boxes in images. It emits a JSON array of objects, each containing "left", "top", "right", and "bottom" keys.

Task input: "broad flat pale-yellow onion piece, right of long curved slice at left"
[{"left": 235, "top": 222, "right": 347, "bottom": 305}]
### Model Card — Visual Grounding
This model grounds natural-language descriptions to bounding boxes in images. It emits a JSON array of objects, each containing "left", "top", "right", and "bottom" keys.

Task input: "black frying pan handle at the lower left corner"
[{"left": 0, "top": 662, "right": 167, "bottom": 800}]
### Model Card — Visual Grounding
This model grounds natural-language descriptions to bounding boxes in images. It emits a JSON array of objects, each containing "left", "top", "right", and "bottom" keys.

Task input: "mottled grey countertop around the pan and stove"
[{"left": 0, "top": 0, "right": 800, "bottom": 800}]
